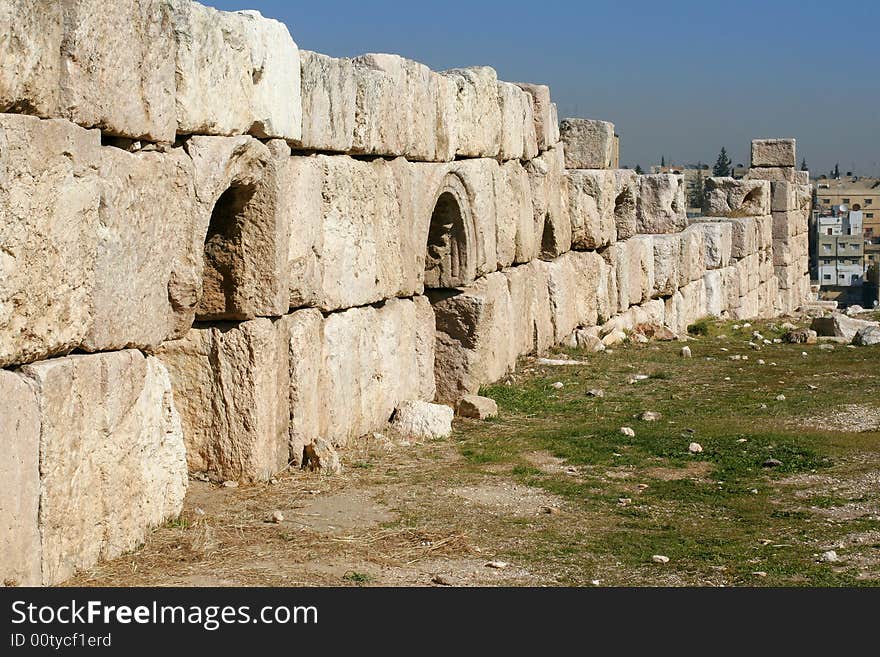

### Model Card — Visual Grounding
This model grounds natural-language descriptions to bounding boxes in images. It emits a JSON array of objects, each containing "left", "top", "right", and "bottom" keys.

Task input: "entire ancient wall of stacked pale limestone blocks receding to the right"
[{"left": 0, "top": 0, "right": 810, "bottom": 584}]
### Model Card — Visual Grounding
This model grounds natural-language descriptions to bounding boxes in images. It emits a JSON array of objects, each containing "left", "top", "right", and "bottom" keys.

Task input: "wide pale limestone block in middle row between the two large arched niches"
[{"left": 285, "top": 155, "right": 422, "bottom": 312}]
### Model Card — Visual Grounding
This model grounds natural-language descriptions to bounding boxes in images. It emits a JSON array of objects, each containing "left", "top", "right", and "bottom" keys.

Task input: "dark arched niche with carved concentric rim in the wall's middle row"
[{"left": 425, "top": 173, "right": 478, "bottom": 289}]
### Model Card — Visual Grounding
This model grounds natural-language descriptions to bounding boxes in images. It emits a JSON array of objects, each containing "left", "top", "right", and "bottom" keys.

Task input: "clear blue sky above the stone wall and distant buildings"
[{"left": 206, "top": 0, "right": 880, "bottom": 175}]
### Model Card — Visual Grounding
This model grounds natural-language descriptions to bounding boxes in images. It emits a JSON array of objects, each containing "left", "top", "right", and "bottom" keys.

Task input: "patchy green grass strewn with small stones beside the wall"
[{"left": 458, "top": 322, "right": 880, "bottom": 586}]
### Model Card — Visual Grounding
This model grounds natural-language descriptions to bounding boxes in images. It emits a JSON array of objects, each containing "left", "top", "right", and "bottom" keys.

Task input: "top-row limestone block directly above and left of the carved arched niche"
[{"left": 353, "top": 53, "right": 458, "bottom": 162}]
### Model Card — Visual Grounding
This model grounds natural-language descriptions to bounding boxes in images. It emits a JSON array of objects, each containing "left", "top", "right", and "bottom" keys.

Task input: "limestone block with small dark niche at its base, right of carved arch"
[{"left": 525, "top": 146, "right": 571, "bottom": 260}]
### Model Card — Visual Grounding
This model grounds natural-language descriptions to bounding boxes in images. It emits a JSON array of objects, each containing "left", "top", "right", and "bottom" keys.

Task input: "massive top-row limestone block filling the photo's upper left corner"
[{"left": 0, "top": 0, "right": 176, "bottom": 142}]
